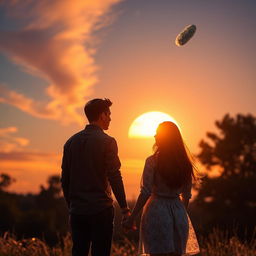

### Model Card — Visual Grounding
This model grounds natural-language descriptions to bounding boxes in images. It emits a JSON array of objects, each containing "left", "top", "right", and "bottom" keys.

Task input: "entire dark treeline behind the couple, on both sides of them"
[{"left": 0, "top": 114, "right": 256, "bottom": 245}]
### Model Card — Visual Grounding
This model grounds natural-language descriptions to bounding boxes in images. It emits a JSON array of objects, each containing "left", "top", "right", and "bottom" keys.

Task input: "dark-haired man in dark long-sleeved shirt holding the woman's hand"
[{"left": 61, "top": 99, "right": 130, "bottom": 256}]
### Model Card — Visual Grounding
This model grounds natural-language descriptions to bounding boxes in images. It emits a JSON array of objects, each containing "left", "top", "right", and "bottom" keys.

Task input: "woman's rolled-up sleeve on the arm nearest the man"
[{"left": 140, "top": 158, "right": 154, "bottom": 197}]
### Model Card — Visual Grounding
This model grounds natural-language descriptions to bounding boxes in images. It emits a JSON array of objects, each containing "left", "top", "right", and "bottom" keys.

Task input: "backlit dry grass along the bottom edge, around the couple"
[{"left": 0, "top": 230, "right": 256, "bottom": 256}]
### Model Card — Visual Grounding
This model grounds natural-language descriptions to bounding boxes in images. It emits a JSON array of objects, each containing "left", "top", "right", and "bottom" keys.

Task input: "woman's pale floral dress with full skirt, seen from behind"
[{"left": 139, "top": 156, "right": 200, "bottom": 255}]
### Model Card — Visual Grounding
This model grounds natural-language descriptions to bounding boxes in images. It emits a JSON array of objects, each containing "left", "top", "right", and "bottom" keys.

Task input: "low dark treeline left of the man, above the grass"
[{"left": 0, "top": 174, "right": 68, "bottom": 245}]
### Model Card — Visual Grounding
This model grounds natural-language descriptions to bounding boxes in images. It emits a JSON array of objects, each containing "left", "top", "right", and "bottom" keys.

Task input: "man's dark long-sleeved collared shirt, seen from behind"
[{"left": 61, "top": 124, "right": 127, "bottom": 215}]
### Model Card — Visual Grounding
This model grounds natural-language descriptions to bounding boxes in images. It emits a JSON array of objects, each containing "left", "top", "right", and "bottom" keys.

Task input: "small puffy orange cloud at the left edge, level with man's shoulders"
[{"left": 0, "top": 126, "right": 29, "bottom": 152}]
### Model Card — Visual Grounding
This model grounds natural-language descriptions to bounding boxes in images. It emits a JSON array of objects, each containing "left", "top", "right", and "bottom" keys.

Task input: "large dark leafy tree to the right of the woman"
[{"left": 193, "top": 114, "right": 256, "bottom": 238}]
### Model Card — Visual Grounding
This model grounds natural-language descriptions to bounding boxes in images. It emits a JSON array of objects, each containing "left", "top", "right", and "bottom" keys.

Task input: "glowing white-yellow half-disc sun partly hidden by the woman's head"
[{"left": 128, "top": 111, "right": 180, "bottom": 138}]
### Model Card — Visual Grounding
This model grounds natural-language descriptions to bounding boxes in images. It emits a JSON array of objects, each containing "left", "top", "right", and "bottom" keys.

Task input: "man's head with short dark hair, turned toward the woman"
[{"left": 84, "top": 99, "right": 112, "bottom": 130}]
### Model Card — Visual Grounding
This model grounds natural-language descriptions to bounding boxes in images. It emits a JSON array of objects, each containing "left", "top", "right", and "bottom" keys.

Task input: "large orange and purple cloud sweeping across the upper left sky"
[{"left": 0, "top": 0, "right": 120, "bottom": 123}]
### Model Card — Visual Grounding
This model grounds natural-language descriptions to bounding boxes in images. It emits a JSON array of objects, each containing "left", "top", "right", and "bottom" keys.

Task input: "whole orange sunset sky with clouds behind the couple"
[{"left": 0, "top": 0, "right": 256, "bottom": 199}]
